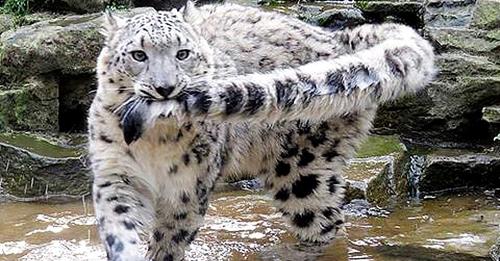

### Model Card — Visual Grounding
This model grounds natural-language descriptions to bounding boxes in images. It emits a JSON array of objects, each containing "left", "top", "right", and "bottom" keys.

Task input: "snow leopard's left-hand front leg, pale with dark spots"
[{"left": 93, "top": 171, "right": 152, "bottom": 261}]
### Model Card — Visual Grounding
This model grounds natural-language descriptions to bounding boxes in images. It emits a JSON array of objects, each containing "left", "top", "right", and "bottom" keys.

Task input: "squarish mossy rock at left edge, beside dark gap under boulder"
[{"left": 0, "top": 77, "right": 59, "bottom": 131}]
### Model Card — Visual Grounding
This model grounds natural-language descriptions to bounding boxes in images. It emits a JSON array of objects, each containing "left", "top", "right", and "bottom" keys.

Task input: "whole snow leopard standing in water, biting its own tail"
[{"left": 88, "top": 2, "right": 435, "bottom": 260}]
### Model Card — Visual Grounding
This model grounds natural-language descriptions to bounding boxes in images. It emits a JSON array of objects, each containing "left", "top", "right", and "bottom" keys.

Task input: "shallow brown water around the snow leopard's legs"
[{"left": 0, "top": 192, "right": 500, "bottom": 261}]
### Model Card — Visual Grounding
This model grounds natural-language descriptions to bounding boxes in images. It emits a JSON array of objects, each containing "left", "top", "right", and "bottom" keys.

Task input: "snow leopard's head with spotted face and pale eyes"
[{"left": 98, "top": 2, "right": 213, "bottom": 100}]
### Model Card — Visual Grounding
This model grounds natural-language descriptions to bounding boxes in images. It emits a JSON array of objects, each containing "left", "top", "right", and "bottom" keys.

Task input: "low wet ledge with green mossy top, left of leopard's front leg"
[{"left": 0, "top": 133, "right": 91, "bottom": 201}]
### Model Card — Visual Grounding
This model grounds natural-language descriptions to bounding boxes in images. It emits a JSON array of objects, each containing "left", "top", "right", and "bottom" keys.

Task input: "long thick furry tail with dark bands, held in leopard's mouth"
[{"left": 124, "top": 23, "right": 436, "bottom": 143}]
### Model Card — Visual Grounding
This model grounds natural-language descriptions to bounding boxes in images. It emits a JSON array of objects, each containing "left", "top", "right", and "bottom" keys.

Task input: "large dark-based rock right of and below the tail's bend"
[{"left": 375, "top": 53, "right": 500, "bottom": 143}]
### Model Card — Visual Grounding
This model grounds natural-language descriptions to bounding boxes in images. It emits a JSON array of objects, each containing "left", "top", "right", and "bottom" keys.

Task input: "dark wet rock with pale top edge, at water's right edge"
[{"left": 418, "top": 150, "right": 500, "bottom": 195}]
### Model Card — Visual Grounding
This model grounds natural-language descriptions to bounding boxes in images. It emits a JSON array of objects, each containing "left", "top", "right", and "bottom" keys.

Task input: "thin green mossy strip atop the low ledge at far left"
[{"left": 0, "top": 133, "right": 83, "bottom": 158}]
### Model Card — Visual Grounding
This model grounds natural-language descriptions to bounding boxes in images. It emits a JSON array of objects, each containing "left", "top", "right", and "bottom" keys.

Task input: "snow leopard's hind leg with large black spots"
[{"left": 266, "top": 108, "right": 375, "bottom": 244}]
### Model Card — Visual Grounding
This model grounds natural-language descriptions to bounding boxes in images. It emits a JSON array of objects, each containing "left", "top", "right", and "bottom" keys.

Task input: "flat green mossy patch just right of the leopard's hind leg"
[{"left": 357, "top": 136, "right": 404, "bottom": 158}]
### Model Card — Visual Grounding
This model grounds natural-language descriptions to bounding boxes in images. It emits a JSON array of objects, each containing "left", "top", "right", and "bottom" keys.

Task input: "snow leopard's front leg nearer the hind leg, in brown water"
[{"left": 147, "top": 141, "right": 224, "bottom": 261}]
